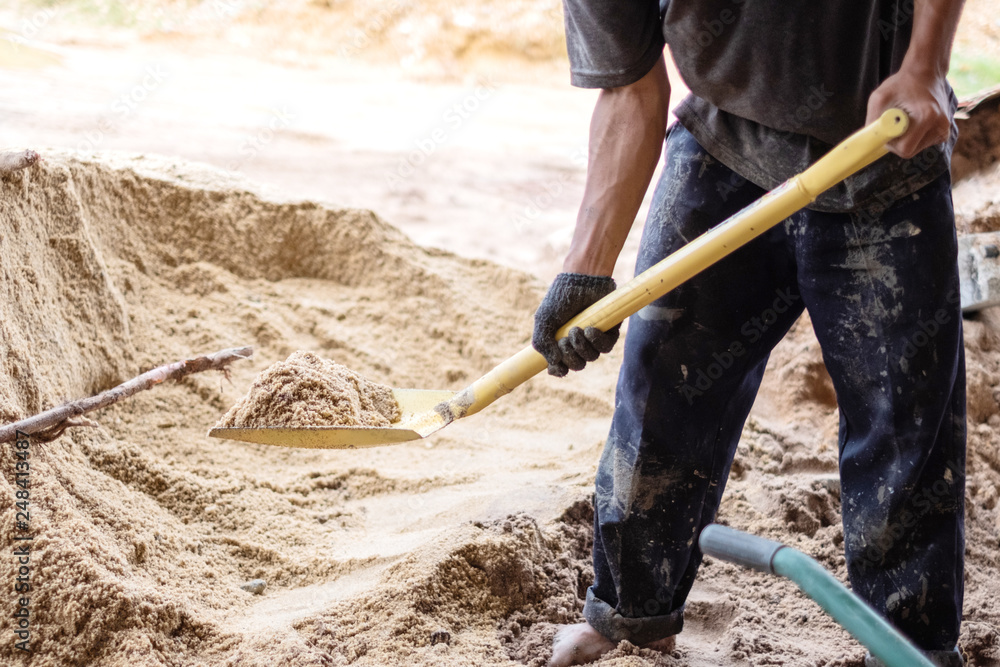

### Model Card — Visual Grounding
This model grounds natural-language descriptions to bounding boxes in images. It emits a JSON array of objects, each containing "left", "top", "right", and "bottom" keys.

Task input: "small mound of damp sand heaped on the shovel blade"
[{"left": 217, "top": 351, "right": 400, "bottom": 428}]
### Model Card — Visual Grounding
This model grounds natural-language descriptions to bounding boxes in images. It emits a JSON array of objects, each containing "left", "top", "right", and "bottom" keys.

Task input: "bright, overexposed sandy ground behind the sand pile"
[{"left": 0, "top": 0, "right": 704, "bottom": 280}]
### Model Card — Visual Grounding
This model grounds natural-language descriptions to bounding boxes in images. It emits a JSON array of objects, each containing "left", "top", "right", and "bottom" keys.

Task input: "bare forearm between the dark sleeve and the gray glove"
[{"left": 563, "top": 58, "right": 670, "bottom": 276}]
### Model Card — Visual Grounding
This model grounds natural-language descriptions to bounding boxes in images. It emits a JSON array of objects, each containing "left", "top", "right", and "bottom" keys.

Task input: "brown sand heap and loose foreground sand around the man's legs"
[{"left": 0, "top": 152, "right": 1000, "bottom": 667}]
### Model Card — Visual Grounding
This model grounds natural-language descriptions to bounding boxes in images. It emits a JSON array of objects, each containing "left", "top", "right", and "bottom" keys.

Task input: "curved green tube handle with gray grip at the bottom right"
[{"left": 698, "top": 524, "right": 934, "bottom": 667}]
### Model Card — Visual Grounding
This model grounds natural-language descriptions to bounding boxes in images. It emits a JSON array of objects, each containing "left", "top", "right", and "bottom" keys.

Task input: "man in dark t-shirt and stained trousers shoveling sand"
[{"left": 533, "top": 0, "right": 965, "bottom": 667}]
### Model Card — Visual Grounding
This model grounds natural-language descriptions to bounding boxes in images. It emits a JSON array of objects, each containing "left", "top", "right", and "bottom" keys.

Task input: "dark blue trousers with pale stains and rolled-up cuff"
[{"left": 584, "top": 125, "right": 965, "bottom": 665}]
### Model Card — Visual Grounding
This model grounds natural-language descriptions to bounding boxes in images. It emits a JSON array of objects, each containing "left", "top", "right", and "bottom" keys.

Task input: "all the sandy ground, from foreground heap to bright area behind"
[{"left": 0, "top": 2, "right": 1000, "bottom": 667}]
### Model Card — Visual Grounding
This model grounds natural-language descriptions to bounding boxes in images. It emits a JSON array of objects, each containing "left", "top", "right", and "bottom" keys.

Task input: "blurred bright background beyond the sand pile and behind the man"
[{"left": 0, "top": 0, "right": 1000, "bottom": 280}]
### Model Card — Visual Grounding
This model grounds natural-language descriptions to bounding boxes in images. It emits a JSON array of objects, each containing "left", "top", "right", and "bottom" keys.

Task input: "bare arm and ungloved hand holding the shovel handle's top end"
[{"left": 868, "top": 0, "right": 964, "bottom": 158}]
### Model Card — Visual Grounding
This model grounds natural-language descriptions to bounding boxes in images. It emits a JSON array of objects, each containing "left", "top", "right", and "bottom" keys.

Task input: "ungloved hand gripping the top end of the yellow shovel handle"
[{"left": 865, "top": 69, "right": 951, "bottom": 159}]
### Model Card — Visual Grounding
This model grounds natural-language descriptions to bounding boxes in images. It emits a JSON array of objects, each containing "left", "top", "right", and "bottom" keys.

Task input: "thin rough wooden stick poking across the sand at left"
[{"left": 0, "top": 347, "right": 253, "bottom": 443}]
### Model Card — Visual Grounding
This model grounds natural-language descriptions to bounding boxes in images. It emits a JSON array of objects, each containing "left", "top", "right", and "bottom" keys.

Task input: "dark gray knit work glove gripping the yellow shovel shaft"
[{"left": 531, "top": 273, "right": 621, "bottom": 377}]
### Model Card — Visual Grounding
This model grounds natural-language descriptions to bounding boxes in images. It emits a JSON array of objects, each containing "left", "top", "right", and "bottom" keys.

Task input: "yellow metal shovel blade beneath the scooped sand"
[{"left": 208, "top": 388, "right": 455, "bottom": 449}]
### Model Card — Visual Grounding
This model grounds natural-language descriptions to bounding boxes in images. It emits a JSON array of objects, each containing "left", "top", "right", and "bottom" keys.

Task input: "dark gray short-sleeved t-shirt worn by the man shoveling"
[{"left": 564, "top": 0, "right": 957, "bottom": 211}]
